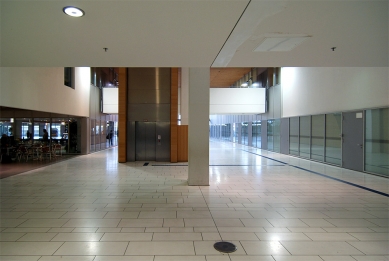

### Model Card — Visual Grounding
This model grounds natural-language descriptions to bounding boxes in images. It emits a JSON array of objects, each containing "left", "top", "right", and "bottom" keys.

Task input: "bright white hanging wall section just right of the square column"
[{"left": 209, "top": 88, "right": 266, "bottom": 114}]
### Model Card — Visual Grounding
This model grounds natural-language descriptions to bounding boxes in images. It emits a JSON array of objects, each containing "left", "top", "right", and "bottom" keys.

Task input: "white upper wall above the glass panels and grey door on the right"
[{"left": 281, "top": 67, "right": 389, "bottom": 117}]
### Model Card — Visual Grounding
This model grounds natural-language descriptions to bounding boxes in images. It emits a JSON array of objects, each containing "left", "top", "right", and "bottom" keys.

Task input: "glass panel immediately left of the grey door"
[{"left": 325, "top": 113, "right": 342, "bottom": 166}]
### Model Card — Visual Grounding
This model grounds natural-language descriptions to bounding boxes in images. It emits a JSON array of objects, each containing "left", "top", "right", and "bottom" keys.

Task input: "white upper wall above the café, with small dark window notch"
[{"left": 0, "top": 67, "right": 90, "bottom": 117}]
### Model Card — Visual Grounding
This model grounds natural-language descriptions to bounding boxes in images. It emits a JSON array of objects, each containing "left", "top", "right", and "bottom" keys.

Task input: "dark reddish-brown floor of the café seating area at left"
[{"left": 0, "top": 155, "right": 80, "bottom": 179}]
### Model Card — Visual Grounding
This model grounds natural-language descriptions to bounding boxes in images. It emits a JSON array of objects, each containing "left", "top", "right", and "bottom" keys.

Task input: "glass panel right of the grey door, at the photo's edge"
[{"left": 365, "top": 108, "right": 389, "bottom": 176}]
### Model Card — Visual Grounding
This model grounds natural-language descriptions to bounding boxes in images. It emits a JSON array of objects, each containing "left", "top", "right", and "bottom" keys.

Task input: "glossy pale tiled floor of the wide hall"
[{"left": 0, "top": 141, "right": 389, "bottom": 261}]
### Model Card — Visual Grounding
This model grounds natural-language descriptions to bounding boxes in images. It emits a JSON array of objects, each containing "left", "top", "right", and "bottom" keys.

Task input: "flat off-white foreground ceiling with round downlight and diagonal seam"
[{"left": 0, "top": 0, "right": 389, "bottom": 68}]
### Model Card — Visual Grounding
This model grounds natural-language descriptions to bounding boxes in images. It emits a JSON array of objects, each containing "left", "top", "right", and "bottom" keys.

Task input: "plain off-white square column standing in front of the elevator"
[{"left": 188, "top": 68, "right": 210, "bottom": 186}]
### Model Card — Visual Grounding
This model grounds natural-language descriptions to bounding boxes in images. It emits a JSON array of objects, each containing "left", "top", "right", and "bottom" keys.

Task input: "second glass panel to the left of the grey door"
[{"left": 311, "top": 114, "right": 325, "bottom": 161}]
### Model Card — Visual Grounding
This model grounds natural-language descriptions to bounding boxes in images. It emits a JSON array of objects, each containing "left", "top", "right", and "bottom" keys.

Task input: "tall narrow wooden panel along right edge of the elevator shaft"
[{"left": 170, "top": 68, "right": 178, "bottom": 162}]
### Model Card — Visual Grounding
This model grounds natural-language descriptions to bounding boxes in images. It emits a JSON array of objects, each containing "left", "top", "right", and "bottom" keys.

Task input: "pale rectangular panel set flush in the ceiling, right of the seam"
[{"left": 254, "top": 36, "right": 309, "bottom": 52}]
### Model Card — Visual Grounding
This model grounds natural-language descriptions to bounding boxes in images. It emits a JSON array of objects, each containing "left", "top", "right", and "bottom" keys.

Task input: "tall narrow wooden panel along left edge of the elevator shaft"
[{"left": 118, "top": 67, "right": 127, "bottom": 163}]
